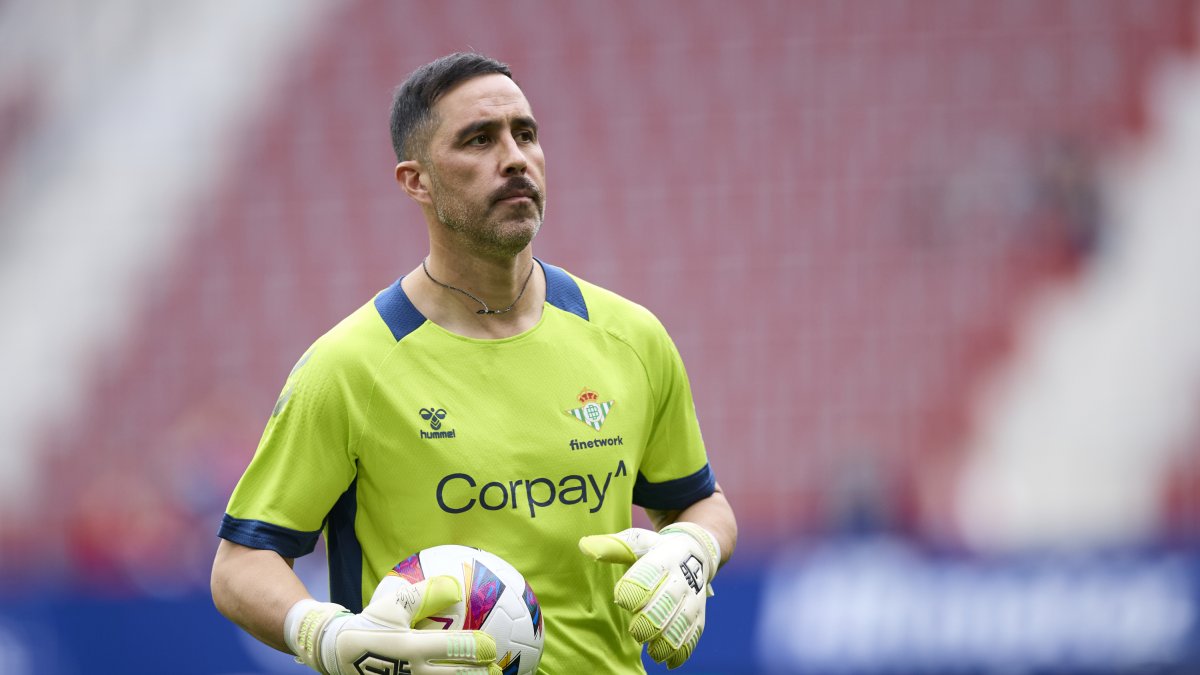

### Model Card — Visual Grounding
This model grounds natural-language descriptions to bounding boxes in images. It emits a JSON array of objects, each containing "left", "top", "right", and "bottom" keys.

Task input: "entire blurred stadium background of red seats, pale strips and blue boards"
[{"left": 0, "top": 0, "right": 1200, "bottom": 675}]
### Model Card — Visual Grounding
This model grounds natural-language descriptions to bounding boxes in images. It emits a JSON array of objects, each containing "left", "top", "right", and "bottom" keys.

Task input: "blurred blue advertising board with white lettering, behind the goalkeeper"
[{"left": 0, "top": 536, "right": 1200, "bottom": 675}]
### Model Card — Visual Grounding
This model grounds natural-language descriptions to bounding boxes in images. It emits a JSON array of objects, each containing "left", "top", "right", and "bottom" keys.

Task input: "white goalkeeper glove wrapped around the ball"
[{"left": 283, "top": 577, "right": 500, "bottom": 675}]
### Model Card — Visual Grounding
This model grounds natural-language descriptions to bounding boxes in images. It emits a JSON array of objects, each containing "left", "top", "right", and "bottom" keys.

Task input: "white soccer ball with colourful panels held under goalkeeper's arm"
[{"left": 388, "top": 544, "right": 546, "bottom": 675}]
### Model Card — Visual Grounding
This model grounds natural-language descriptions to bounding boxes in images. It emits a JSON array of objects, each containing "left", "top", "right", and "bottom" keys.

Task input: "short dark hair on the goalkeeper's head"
[{"left": 390, "top": 52, "right": 512, "bottom": 162}]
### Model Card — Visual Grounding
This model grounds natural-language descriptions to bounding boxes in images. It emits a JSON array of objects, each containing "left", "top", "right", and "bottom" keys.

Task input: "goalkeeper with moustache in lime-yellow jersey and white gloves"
[{"left": 212, "top": 54, "right": 737, "bottom": 675}]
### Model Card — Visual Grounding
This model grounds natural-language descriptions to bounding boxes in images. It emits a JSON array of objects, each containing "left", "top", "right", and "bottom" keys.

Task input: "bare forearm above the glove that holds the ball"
[{"left": 211, "top": 539, "right": 311, "bottom": 653}]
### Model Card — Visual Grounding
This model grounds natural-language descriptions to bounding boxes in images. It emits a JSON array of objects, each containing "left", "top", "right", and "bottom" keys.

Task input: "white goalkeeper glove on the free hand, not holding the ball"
[{"left": 580, "top": 522, "right": 721, "bottom": 668}]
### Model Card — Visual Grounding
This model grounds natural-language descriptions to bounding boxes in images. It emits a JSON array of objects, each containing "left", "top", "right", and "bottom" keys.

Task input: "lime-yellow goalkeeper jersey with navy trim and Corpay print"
[{"left": 220, "top": 261, "right": 714, "bottom": 675}]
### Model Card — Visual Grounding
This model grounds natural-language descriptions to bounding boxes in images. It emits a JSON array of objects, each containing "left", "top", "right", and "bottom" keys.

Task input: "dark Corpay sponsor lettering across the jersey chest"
[{"left": 437, "top": 460, "right": 629, "bottom": 518}]
